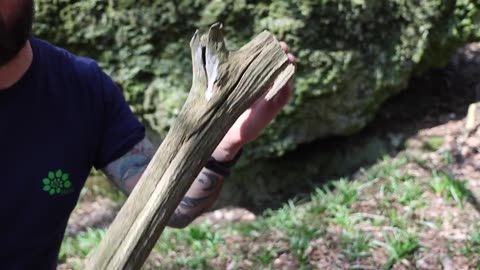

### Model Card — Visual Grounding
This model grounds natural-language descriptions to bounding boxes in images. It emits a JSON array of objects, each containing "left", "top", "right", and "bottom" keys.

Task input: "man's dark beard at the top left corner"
[{"left": 0, "top": 0, "right": 34, "bottom": 66}]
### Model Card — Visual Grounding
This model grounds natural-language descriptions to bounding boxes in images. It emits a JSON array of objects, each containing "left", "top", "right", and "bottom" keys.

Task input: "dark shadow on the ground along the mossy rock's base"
[{"left": 228, "top": 43, "right": 480, "bottom": 213}]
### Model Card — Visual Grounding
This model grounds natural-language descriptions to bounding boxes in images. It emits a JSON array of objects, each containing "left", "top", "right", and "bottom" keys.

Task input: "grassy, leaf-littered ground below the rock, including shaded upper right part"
[{"left": 60, "top": 44, "right": 480, "bottom": 270}]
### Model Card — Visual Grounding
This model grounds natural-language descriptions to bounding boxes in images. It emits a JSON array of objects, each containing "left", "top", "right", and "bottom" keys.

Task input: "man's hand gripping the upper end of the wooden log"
[{"left": 212, "top": 42, "right": 295, "bottom": 161}]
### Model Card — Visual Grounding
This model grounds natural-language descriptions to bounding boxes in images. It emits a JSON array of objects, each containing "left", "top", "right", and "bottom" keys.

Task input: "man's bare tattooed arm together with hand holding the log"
[{"left": 102, "top": 42, "right": 295, "bottom": 228}]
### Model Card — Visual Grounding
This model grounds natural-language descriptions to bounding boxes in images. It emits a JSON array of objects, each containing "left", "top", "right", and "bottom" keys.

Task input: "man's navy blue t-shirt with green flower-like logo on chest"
[{"left": 0, "top": 38, "right": 145, "bottom": 270}]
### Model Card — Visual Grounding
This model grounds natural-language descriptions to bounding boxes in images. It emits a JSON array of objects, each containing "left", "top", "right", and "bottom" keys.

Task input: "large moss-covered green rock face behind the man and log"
[{"left": 35, "top": 0, "right": 480, "bottom": 209}]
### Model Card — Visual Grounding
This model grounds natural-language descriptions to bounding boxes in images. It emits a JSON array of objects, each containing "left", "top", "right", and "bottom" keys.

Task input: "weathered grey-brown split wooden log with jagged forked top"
[{"left": 86, "top": 24, "right": 295, "bottom": 270}]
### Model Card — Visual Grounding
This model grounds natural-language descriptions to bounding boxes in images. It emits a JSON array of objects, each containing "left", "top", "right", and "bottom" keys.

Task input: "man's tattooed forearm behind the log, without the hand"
[{"left": 102, "top": 139, "right": 223, "bottom": 228}]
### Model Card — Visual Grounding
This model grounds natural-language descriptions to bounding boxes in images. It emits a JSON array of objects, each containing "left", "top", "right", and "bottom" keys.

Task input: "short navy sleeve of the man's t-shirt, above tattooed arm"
[{"left": 93, "top": 65, "right": 145, "bottom": 169}]
